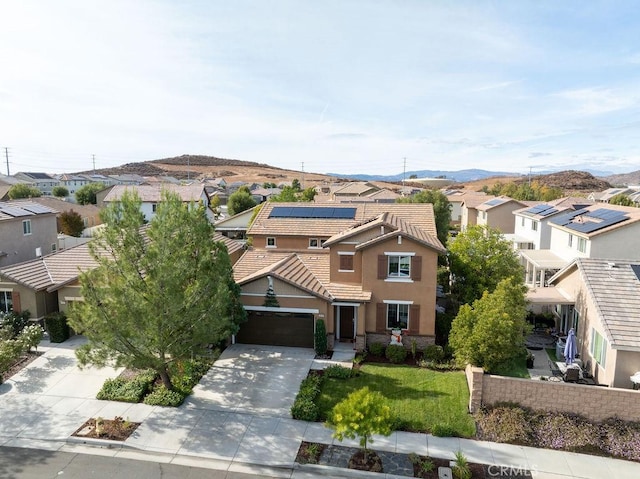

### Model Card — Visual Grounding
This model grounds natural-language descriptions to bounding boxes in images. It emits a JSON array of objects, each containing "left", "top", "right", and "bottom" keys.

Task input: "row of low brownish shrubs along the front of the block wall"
[{"left": 476, "top": 404, "right": 640, "bottom": 461}]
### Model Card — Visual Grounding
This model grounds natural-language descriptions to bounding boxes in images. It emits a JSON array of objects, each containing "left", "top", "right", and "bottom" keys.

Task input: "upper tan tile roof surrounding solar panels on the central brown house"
[{"left": 247, "top": 202, "right": 437, "bottom": 237}]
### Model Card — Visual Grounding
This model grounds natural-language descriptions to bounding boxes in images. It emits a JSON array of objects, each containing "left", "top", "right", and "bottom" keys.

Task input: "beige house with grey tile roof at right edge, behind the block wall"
[{"left": 546, "top": 258, "right": 640, "bottom": 388}]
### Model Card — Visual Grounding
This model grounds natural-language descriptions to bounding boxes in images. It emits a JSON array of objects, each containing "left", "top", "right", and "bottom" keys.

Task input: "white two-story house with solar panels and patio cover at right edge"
[{"left": 520, "top": 204, "right": 640, "bottom": 286}]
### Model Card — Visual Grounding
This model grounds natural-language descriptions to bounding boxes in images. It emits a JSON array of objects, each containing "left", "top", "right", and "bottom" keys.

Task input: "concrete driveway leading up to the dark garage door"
[{"left": 185, "top": 344, "right": 315, "bottom": 418}]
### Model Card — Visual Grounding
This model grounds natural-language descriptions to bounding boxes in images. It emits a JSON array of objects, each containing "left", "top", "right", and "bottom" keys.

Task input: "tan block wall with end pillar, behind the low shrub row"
[{"left": 465, "top": 366, "right": 640, "bottom": 421}]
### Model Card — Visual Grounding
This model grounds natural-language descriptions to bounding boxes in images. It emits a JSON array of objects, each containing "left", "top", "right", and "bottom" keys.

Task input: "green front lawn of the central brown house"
[{"left": 317, "top": 364, "right": 475, "bottom": 437}]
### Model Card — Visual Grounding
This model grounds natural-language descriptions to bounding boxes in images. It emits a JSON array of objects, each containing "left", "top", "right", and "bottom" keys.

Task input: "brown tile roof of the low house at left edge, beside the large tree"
[{"left": 0, "top": 243, "right": 97, "bottom": 291}]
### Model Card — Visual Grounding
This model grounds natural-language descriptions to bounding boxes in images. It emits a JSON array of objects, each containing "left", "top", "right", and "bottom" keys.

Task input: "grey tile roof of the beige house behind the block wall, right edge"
[{"left": 558, "top": 258, "right": 640, "bottom": 350}]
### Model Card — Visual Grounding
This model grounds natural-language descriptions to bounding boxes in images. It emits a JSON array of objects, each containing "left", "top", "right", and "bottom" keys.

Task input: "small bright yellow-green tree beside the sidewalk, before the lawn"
[{"left": 327, "top": 387, "right": 393, "bottom": 462}]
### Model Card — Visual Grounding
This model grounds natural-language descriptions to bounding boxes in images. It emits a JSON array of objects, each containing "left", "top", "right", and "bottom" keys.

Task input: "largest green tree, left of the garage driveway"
[{"left": 69, "top": 192, "right": 245, "bottom": 389}]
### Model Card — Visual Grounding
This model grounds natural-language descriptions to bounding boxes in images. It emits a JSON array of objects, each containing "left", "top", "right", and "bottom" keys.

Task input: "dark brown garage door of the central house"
[{"left": 236, "top": 311, "right": 313, "bottom": 348}]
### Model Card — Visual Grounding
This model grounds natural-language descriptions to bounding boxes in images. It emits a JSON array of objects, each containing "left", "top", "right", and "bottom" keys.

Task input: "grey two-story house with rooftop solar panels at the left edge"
[{"left": 0, "top": 200, "right": 58, "bottom": 267}]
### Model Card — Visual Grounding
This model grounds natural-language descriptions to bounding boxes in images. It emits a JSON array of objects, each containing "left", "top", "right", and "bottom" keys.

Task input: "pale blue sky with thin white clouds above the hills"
[{"left": 0, "top": 0, "right": 640, "bottom": 174}]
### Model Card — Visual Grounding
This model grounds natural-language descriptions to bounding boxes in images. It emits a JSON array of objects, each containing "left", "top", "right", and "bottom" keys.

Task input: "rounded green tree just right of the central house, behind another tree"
[{"left": 449, "top": 225, "right": 524, "bottom": 304}]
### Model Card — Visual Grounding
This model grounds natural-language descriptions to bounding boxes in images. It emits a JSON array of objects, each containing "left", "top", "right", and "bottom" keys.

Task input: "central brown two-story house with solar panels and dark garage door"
[{"left": 234, "top": 202, "right": 445, "bottom": 350}]
